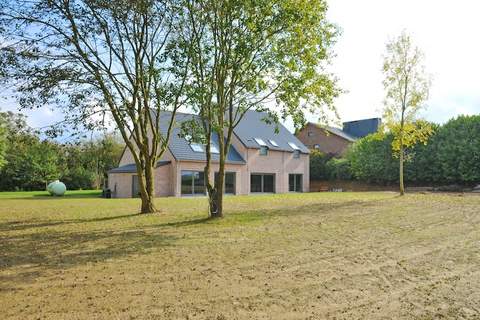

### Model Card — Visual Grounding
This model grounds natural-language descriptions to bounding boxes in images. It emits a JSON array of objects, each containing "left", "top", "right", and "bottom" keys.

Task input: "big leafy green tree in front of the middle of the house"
[{"left": 177, "top": 0, "right": 339, "bottom": 217}]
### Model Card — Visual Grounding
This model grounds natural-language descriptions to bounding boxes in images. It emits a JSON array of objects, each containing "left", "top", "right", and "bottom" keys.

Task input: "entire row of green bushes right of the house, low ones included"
[{"left": 311, "top": 116, "right": 480, "bottom": 184}]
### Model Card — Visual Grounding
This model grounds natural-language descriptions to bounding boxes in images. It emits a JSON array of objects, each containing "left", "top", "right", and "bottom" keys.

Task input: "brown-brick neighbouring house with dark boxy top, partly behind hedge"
[{"left": 296, "top": 118, "right": 381, "bottom": 156}]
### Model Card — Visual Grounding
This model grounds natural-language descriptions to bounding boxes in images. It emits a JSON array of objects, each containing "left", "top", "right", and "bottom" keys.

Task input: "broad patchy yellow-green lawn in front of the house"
[{"left": 0, "top": 193, "right": 480, "bottom": 320}]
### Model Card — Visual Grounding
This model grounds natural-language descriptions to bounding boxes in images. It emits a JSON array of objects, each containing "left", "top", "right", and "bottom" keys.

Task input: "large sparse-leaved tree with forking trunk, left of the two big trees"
[{"left": 0, "top": 0, "right": 189, "bottom": 213}]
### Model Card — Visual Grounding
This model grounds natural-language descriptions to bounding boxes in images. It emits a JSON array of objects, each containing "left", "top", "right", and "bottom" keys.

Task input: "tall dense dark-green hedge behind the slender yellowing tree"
[{"left": 347, "top": 116, "right": 480, "bottom": 184}]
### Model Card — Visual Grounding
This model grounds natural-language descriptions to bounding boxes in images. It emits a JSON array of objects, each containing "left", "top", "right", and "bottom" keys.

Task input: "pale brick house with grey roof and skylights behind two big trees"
[{"left": 108, "top": 111, "right": 310, "bottom": 198}]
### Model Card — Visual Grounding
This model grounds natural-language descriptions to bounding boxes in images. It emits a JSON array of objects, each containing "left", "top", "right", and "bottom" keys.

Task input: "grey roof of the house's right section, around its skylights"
[{"left": 234, "top": 111, "right": 309, "bottom": 153}]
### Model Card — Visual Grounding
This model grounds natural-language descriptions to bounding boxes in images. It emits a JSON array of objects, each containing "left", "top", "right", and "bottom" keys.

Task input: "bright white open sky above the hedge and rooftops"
[{"left": 0, "top": 0, "right": 480, "bottom": 131}]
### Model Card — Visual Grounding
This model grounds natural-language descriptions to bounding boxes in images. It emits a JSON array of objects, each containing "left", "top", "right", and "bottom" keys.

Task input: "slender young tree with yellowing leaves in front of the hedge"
[{"left": 383, "top": 31, "right": 432, "bottom": 195}]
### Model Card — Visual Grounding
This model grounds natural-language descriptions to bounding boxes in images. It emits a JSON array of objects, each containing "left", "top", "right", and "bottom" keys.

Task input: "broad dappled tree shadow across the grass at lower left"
[{"left": 0, "top": 229, "right": 178, "bottom": 282}]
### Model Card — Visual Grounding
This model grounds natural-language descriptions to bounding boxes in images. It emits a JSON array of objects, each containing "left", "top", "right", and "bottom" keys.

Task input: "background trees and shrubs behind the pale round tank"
[{"left": 0, "top": 112, "right": 123, "bottom": 191}]
